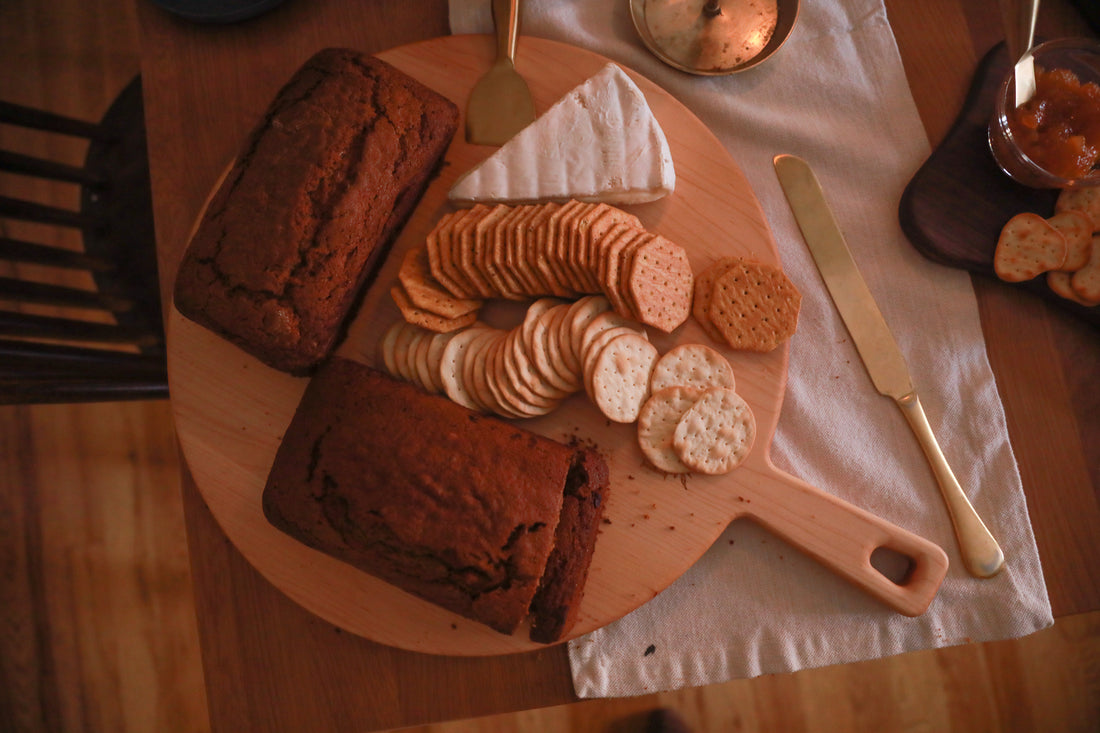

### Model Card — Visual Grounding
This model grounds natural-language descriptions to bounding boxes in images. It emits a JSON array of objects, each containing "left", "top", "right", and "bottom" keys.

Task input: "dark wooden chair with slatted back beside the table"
[{"left": 0, "top": 76, "right": 168, "bottom": 404}]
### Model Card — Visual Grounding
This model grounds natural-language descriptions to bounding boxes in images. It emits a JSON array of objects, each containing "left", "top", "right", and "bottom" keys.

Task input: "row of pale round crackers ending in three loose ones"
[{"left": 382, "top": 296, "right": 756, "bottom": 473}]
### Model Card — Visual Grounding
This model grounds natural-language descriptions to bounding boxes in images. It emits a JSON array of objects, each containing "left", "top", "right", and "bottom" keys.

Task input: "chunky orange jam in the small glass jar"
[{"left": 1009, "top": 67, "right": 1100, "bottom": 178}]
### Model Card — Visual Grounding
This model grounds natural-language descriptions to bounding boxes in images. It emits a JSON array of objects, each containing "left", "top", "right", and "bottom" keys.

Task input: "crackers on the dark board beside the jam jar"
[{"left": 993, "top": 188, "right": 1100, "bottom": 307}]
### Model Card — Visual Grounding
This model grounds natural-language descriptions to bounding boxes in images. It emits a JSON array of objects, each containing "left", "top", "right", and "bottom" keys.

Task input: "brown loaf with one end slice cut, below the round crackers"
[{"left": 263, "top": 357, "right": 607, "bottom": 641}]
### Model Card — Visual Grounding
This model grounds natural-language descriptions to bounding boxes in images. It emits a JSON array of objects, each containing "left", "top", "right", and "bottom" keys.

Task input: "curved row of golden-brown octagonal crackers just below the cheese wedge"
[{"left": 393, "top": 200, "right": 694, "bottom": 332}]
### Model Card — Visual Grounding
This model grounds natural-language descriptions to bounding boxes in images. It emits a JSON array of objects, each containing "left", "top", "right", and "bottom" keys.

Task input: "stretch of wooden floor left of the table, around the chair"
[{"left": 0, "top": 0, "right": 209, "bottom": 732}]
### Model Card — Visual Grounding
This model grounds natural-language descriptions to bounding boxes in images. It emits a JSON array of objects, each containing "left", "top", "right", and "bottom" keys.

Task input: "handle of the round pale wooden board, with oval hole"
[{"left": 738, "top": 469, "right": 948, "bottom": 616}]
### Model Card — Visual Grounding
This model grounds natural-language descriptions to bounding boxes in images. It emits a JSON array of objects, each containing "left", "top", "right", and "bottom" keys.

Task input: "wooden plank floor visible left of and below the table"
[{"left": 0, "top": 0, "right": 1100, "bottom": 733}]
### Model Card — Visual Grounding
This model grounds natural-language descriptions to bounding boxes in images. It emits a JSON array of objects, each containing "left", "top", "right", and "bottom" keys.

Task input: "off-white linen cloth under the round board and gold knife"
[{"left": 451, "top": 0, "right": 1053, "bottom": 698}]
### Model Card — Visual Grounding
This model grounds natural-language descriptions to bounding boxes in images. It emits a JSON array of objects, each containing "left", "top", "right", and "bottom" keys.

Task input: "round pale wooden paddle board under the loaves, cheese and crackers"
[{"left": 168, "top": 36, "right": 946, "bottom": 655}]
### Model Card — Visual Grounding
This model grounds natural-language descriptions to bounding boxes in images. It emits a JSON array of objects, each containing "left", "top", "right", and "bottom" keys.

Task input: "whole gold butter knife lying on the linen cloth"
[{"left": 772, "top": 155, "right": 1004, "bottom": 578}]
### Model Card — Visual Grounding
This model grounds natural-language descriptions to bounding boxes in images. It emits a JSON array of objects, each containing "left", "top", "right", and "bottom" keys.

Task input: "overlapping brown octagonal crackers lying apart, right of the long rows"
[{"left": 692, "top": 256, "right": 802, "bottom": 352}]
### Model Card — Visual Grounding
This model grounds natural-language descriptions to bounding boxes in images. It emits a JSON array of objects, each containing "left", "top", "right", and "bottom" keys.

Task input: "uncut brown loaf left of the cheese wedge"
[{"left": 175, "top": 48, "right": 459, "bottom": 374}]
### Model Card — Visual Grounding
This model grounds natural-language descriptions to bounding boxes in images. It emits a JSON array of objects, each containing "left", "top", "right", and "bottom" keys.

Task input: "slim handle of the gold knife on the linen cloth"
[{"left": 895, "top": 392, "right": 1004, "bottom": 578}]
